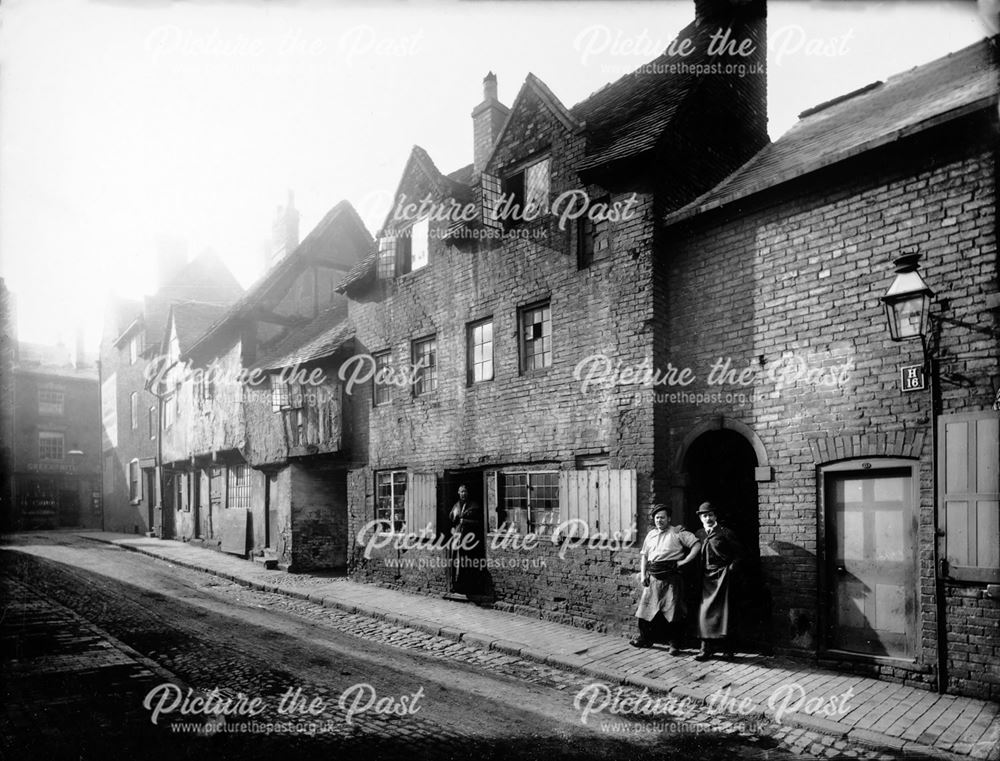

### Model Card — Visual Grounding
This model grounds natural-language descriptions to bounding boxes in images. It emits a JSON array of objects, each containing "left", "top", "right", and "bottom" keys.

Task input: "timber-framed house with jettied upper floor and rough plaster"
[{"left": 154, "top": 202, "right": 371, "bottom": 570}]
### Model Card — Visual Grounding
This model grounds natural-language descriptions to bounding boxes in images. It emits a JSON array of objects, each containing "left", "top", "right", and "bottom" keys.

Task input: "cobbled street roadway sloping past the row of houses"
[{"left": 0, "top": 534, "right": 916, "bottom": 759}]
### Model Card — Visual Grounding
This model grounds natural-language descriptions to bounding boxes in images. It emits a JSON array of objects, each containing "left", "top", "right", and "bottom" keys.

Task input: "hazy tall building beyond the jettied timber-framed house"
[{"left": 100, "top": 249, "right": 243, "bottom": 533}]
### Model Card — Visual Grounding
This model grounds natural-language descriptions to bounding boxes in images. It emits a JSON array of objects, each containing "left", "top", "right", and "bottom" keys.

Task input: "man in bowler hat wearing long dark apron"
[{"left": 695, "top": 502, "right": 743, "bottom": 661}]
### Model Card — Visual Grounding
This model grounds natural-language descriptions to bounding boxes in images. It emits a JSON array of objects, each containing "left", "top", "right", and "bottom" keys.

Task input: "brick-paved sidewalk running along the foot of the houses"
[{"left": 79, "top": 532, "right": 1000, "bottom": 759}]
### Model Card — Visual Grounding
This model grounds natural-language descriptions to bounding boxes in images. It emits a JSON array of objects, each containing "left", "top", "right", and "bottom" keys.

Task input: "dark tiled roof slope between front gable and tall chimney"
[{"left": 570, "top": 16, "right": 718, "bottom": 169}]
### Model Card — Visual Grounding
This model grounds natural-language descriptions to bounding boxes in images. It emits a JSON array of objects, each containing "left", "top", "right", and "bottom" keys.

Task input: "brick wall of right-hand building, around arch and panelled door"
[{"left": 655, "top": 124, "right": 1000, "bottom": 697}]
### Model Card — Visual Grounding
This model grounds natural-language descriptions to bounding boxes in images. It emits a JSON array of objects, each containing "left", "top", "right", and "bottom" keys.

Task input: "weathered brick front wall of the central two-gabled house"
[{"left": 349, "top": 89, "right": 653, "bottom": 628}]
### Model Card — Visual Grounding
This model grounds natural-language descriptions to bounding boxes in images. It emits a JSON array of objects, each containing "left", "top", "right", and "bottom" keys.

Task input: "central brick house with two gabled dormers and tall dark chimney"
[{"left": 342, "top": 2, "right": 767, "bottom": 630}]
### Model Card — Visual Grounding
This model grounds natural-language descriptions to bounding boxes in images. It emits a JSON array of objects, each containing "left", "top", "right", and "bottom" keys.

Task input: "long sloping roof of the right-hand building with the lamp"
[{"left": 666, "top": 37, "right": 1000, "bottom": 224}]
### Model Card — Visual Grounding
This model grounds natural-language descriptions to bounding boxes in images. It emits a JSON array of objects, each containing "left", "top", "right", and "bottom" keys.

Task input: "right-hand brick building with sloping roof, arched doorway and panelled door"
[{"left": 654, "top": 38, "right": 1000, "bottom": 699}]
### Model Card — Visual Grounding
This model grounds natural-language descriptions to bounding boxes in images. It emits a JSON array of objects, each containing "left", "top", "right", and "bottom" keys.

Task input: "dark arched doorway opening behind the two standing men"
[{"left": 682, "top": 427, "right": 771, "bottom": 652}]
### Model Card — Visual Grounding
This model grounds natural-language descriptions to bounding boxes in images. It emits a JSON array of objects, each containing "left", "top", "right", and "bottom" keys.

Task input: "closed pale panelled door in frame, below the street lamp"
[{"left": 827, "top": 468, "right": 917, "bottom": 658}]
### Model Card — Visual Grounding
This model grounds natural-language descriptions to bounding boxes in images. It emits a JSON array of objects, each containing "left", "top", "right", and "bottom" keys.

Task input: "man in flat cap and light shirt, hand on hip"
[{"left": 630, "top": 504, "right": 701, "bottom": 655}]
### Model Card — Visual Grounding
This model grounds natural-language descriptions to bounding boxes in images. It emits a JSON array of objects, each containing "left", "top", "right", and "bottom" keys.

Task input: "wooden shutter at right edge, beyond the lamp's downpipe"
[{"left": 938, "top": 410, "right": 1000, "bottom": 582}]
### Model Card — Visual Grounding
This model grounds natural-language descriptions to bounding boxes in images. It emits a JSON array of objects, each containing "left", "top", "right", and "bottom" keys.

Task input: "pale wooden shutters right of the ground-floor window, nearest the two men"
[{"left": 559, "top": 468, "right": 636, "bottom": 538}]
